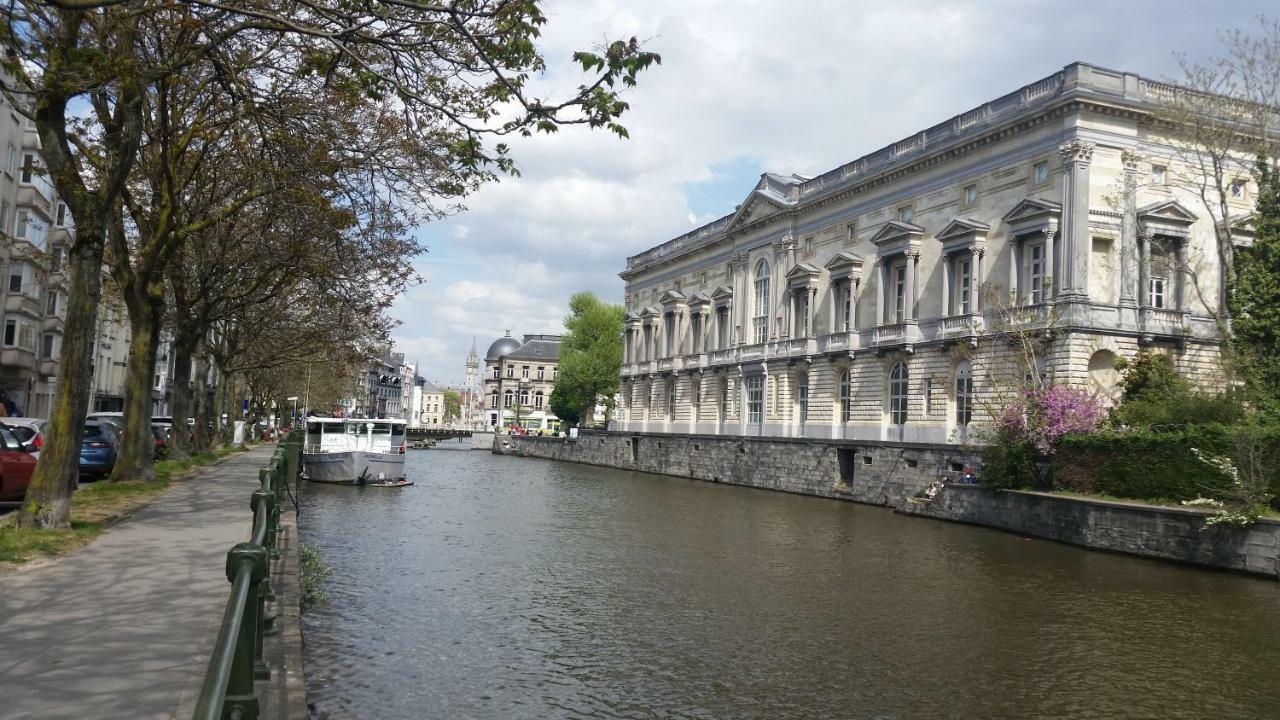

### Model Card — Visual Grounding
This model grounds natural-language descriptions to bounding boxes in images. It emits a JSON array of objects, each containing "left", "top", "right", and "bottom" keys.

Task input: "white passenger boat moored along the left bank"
[{"left": 302, "top": 418, "right": 406, "bottom": 486}]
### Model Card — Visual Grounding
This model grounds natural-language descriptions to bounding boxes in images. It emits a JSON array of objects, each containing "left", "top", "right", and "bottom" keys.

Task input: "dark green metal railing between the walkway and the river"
[{"left": 192, "top": 430, "right": 302, "bottom": 720}]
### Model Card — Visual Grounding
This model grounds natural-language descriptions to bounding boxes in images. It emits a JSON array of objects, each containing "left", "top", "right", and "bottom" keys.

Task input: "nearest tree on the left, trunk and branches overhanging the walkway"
[{"left": 0, "top": 0, "right": 659, "bottom": 528}]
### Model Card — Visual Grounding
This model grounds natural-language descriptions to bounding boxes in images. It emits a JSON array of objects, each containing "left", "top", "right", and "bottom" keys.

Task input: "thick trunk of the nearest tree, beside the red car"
[{"left": 17, "top": 235, "right": 102, "bottom": 528}]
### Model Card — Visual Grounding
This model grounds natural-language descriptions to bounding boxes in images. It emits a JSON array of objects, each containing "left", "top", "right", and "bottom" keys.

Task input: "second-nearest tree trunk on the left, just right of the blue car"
[{"left": 111, "top": 292, "right": 164, "bottom": 483}]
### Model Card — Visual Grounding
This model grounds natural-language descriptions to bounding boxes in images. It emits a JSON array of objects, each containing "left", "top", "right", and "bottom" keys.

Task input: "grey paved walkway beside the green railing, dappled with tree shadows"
[{"left": 0, "top": 446, "right": 271, "bottom": 720}]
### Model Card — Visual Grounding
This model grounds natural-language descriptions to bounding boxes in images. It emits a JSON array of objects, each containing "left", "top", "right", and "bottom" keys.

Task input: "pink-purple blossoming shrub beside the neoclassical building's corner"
[{"left": 996, "top": 386, "right": 1107, "bottom": 456}]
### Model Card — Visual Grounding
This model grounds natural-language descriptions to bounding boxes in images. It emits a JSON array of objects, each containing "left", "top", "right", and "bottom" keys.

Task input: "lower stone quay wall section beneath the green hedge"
[{"left": 899, "top": 484, "right": 1280, "bottom": 578}]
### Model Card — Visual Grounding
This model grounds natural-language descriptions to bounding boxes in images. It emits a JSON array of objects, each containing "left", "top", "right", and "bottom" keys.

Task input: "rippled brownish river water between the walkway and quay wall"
[{"left": 301, "top": 443, "right": 1280, "bottom": 720}]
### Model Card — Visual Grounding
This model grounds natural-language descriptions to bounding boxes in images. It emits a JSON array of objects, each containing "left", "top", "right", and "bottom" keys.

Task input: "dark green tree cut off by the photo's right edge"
[{"left": 1231, "top": 158, "right": 1280, "bottom": 420}]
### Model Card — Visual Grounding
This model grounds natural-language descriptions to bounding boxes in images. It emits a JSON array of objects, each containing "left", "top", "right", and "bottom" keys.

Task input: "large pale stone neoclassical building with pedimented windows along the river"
[{"left": 616, "top": 63, "right": 1253, "bottom": 443}]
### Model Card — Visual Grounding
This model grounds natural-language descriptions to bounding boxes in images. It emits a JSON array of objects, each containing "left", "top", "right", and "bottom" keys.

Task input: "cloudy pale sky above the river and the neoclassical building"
[{"left": 394, "top": 0, "right": 1274, "bottom": 383}]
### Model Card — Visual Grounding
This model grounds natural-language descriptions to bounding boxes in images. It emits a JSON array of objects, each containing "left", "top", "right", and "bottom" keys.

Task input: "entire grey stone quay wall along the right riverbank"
[{"left": 493, "top": 432, "right": 1280, "bottom": 578}]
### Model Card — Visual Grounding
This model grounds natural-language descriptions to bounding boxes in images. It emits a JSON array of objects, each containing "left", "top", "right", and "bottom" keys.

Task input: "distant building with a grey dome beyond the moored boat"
[{"left": 484, "top": 331, "right": 561, "bottom": 432}]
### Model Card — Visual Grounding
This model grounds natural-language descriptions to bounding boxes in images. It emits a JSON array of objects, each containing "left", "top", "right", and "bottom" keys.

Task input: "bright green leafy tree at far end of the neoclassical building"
[{"left": 550, "top": 292, "right": 625, "bottom": 425}]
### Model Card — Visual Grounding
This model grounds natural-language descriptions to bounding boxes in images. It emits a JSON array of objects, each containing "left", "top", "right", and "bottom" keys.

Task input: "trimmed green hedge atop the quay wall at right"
[{"left": 1053, "top": 425, "right": 1280, "bottom": 502}]
